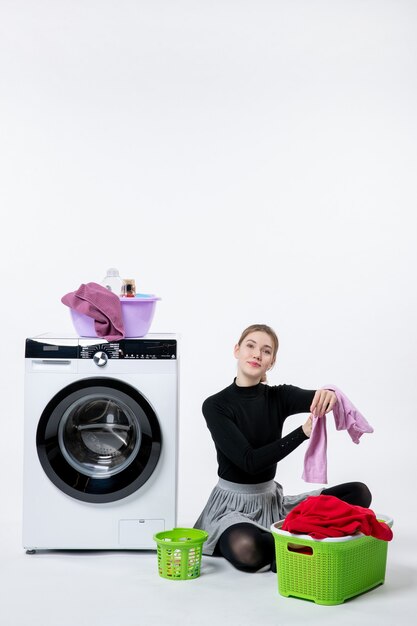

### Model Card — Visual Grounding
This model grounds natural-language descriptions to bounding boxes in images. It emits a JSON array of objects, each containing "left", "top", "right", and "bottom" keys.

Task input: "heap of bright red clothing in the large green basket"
[{"left": 282, "top": 495, "right": 393, "bottom": 541}]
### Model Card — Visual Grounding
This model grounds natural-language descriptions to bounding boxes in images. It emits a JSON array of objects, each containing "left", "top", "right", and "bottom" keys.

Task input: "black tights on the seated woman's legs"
[{"left": 214, "top": 482, "right": 372, "bottom": 572}]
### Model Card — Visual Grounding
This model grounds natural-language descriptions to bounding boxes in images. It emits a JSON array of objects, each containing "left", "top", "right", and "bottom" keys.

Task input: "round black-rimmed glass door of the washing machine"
[{"left": 36, "top": 378, "right": 161, "bottom": 503}]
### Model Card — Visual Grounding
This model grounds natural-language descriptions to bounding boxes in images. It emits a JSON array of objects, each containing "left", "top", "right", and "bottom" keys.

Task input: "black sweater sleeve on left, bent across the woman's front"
[{"left": 203, "top": 401, "right": 308, "bottom": 474}]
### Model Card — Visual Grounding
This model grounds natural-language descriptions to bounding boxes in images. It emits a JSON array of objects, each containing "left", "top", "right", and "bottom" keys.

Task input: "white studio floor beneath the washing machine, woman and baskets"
[{"left": 0, "top": 523, "right": 417, "bottom": 626}]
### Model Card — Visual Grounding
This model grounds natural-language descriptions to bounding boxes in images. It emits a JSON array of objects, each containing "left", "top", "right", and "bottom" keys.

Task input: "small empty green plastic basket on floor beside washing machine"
[{"left": 153, "top": 528, "right": 208, "bottom": 580}]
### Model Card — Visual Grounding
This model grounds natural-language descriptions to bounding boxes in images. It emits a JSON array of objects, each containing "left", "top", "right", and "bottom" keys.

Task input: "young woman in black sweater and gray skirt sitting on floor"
[{"left": 195, "top": 324, "right": 371, "bottom": 572}]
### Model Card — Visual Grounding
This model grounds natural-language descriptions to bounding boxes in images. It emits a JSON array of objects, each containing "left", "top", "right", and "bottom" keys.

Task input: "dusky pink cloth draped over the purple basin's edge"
[{"left": 61, "top": 283, "right": 125, "bottom": 341}]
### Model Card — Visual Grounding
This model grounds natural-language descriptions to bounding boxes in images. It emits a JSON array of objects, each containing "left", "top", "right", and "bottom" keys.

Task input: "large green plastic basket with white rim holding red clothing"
[{"left": 271, "top": 515, "right": 392, "bottom": 605}]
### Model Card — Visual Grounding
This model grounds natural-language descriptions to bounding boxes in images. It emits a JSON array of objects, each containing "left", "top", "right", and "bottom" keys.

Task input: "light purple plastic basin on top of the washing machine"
[{"left": 70, "top": 296, "right": 161, "bottom": 337}]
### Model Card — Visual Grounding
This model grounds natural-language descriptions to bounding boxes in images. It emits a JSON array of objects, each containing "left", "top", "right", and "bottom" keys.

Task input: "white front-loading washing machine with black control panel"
[{"left": 23, "top": 334, "right": 178, "bottom": 551}]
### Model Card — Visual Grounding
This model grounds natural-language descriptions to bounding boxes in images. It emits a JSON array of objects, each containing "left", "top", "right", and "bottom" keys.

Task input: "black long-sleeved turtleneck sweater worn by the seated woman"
[{"left": 203, "top": 382, "right": 315, "bottom": 484}]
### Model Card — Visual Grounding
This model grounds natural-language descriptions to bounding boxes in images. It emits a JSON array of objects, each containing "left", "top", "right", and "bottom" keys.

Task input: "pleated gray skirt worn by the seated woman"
[{"left": 194, "top": 478, "right": 322, "bottom": 556}]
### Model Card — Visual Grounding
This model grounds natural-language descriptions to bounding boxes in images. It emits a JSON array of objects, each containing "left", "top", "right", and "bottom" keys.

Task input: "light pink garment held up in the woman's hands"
[{"left": 302, "top": 385, "right": 374, "bottom": 484}]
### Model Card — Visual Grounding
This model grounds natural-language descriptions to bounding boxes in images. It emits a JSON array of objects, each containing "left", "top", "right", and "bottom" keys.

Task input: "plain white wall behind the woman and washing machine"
[{"left": 0, "top": 0, "right": 417, "bottom": 523}]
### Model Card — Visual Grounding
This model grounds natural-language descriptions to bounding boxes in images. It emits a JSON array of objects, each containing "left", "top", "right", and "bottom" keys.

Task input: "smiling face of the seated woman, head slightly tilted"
[{"left": 234, "top": 331, "right": 274, "bottom": 384}]
